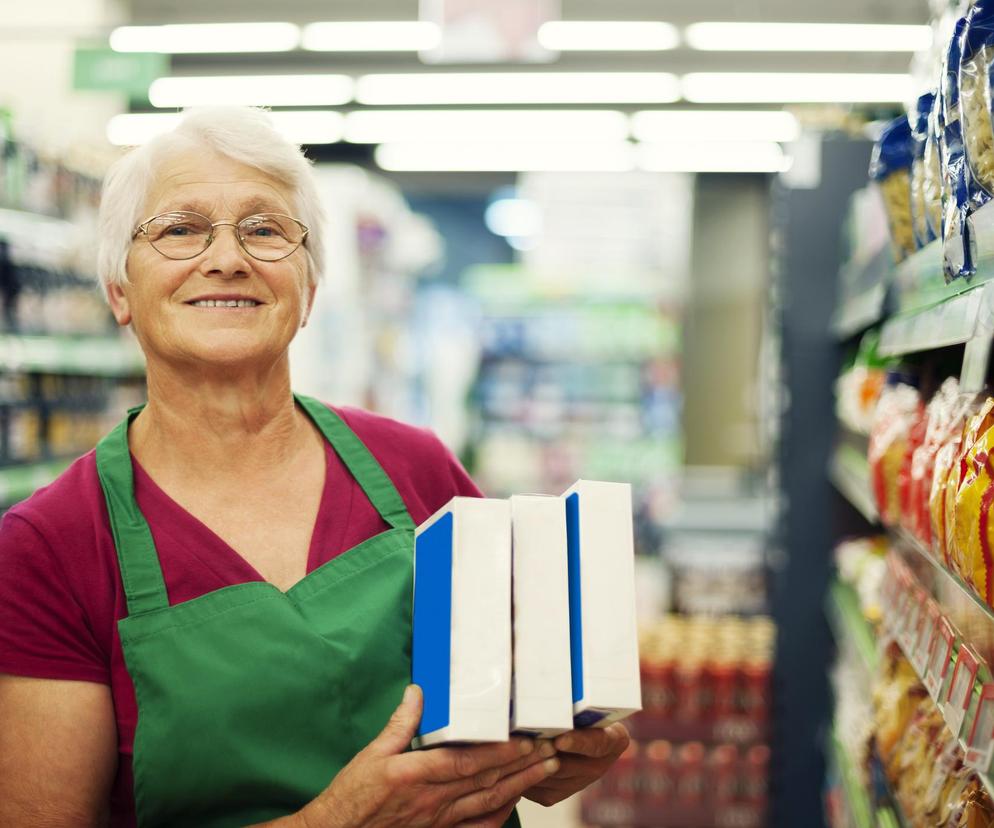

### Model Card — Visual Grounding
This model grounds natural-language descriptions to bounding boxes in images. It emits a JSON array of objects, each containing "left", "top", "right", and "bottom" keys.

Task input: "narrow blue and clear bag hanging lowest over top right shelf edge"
[{"left": 940, "top": 18, "right": 975, "bottom": 282}]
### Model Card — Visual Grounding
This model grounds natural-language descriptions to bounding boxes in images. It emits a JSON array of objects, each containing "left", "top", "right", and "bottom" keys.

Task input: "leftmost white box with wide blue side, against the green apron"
[{"left": 412, "top": 497, "right": 511, "bottom": 747}]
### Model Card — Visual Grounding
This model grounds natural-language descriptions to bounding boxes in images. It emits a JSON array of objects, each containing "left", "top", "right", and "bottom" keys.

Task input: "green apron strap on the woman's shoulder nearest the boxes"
[{"left": 293, "top": 394, "right": 415, "bottom": 530}]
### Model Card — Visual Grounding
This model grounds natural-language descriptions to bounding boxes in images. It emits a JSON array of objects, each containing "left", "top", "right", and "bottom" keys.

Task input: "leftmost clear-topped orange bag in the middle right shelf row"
[{"left": 867, "top": 383, "right": 921, "bottom": 524}]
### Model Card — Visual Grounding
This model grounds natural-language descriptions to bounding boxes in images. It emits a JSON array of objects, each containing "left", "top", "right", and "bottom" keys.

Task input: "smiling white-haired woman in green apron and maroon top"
[{"left": 0, "top": 109, "right": 628, "bottom": 828}]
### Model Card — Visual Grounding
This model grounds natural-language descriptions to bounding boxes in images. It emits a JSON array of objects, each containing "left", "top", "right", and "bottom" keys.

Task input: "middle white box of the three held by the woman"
[{"left": 511, "top": 495, "right": 573, "bottom": 738}]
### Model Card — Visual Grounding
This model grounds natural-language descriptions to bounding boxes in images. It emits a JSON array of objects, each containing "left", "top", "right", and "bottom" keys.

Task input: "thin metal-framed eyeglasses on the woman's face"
[{"left": 131, "top": 210, "right": 308, "bottom": 262}]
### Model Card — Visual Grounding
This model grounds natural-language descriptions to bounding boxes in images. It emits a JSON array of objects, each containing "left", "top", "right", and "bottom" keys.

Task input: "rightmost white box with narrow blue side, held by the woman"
[{"left": 563, "top": 480, "right": 642, "bottom": 727}]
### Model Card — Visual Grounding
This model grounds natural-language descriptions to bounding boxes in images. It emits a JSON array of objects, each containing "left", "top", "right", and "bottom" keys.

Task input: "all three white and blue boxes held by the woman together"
[{"left": 413, "top": 480, "right": 641, "bottom": 747}]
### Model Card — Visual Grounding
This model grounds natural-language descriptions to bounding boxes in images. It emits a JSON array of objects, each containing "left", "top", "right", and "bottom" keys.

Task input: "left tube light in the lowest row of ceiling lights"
[{"left": 374, "top": 141, "right": 635, "bottom": 172}]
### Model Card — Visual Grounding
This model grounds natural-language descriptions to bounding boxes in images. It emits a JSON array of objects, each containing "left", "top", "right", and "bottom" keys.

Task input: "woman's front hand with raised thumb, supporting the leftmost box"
[{"left": 296, "top": 685, "right": 559, "bottom": 828}]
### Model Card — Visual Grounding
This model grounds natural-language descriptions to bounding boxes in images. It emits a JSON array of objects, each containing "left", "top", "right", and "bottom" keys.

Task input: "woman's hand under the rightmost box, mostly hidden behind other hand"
[{"left": 524, "top": 722, "right": 629, "bottom": 806}]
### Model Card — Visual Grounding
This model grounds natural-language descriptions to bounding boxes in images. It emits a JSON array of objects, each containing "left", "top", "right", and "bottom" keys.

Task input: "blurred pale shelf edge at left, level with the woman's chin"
[{"left": 0, "top": 334, "right": 145, "bottom": 377}]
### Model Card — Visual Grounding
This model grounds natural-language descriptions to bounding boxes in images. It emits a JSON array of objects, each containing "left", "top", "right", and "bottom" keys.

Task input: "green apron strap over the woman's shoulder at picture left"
[{"left": 97, "top": 406, "right": 169, "bottom": 615}]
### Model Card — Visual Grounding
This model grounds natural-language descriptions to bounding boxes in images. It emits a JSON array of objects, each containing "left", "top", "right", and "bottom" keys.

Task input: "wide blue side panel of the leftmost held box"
[{"left": 411, "top": 512, "right": 452, "bottom": 736}]
